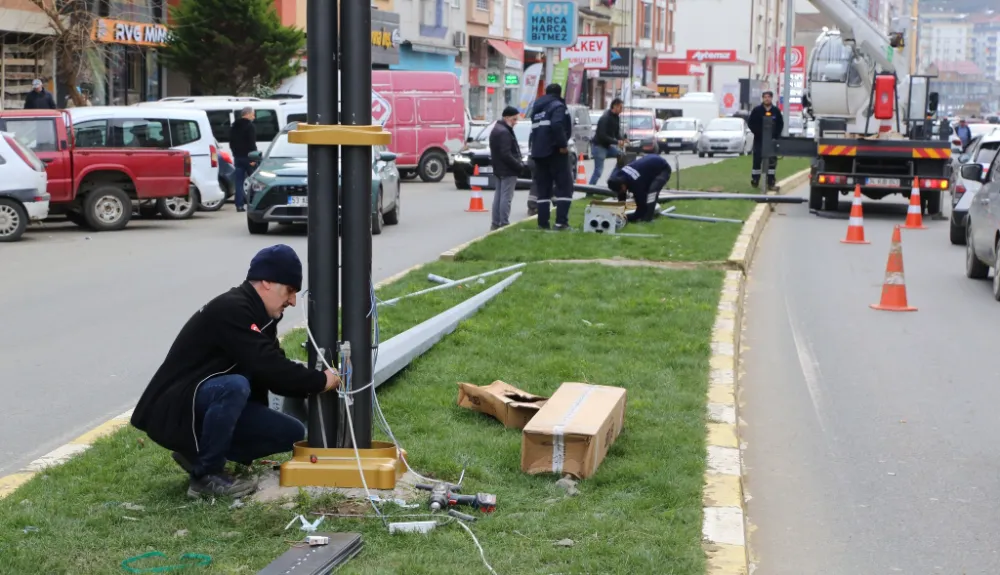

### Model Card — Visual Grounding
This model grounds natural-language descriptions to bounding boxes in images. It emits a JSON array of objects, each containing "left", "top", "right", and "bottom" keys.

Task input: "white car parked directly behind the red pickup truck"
[{"left": 70, "top": 106, "right": 226, "bottom": 219}]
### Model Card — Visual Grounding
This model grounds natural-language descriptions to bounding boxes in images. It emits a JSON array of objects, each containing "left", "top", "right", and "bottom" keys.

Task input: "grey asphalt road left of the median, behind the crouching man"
[{"left": 0, "top": 155, "right": 711, "bottom": 482}]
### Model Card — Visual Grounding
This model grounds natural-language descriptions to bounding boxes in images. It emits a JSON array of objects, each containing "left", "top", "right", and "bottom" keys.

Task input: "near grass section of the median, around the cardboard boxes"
[{"left": 0, "top": 262, "right": 723, "bottom": 575}]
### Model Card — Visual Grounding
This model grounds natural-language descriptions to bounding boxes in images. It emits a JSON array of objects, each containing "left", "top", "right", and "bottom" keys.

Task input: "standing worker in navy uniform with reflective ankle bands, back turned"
[{"left": 528, "top": 84, "right": 573, "bottom": 230}]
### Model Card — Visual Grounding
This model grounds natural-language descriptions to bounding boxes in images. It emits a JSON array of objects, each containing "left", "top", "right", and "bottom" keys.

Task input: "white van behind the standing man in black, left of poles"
[{"left": 136, "top": 96, "right": 306, "bottom": 153}]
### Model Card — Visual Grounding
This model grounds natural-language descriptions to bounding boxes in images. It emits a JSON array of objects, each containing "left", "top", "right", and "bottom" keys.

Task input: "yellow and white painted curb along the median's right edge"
[{"left": 702, "top": 170, "right": 809, "bottom": 575}]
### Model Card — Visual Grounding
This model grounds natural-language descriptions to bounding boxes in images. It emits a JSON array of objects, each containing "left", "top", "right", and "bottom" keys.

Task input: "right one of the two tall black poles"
[{"left": 344, "top": 2, "right": 375, "bottom": 449}]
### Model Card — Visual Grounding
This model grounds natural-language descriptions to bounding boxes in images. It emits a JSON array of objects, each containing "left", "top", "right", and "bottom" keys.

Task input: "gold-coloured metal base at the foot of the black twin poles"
[{"left": 281, "top": 441, "right": 406, "bottom": 489}]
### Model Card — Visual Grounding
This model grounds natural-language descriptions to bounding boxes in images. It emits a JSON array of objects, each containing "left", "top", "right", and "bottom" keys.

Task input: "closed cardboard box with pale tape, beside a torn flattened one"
[{"left": 521, "top": 383, "right": 626, "bottom": 479}]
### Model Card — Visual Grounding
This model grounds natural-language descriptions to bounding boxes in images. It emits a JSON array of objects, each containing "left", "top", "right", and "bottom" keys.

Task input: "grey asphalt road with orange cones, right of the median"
[{"left": 740, "top": 190, "right": 1000, "bottom": 575}]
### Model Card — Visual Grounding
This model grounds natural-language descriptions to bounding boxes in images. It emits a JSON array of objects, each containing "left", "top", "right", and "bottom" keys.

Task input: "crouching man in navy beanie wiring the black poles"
[{"left": 132, "top": 244, "right": 340, "bottom": 497}]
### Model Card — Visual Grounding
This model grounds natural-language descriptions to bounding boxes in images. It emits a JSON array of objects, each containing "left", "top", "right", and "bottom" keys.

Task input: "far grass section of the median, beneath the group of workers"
[{"left": 455, "top": 156, "right": 809, "bottom": 262}]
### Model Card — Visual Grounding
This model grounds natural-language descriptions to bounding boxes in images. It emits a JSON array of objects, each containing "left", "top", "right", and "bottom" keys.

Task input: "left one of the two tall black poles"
[{"left": 306, "top": 0, "right": 340, "bottom": 447}]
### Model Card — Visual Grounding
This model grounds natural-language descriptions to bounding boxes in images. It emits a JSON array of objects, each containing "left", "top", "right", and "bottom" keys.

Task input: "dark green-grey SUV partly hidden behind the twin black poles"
[{"left": 247, "top": 122, "right": 400, "bottom": 235}]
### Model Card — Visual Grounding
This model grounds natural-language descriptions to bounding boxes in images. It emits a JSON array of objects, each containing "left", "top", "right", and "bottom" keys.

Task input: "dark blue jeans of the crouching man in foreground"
[{"left": 190, "top": 375, "right": 306, "bottom": 477}]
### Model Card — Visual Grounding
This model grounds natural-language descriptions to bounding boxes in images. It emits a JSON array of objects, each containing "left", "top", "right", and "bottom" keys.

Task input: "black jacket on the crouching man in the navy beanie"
[{"left": 132, "top": 282, "right": 326, "bottom": 453}]
